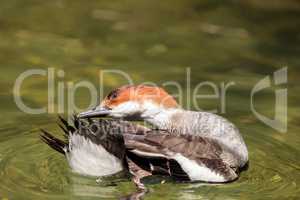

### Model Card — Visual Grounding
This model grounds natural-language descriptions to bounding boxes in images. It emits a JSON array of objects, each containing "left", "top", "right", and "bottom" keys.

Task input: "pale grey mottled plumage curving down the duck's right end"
[{"left": 169, "top": 111, "right": 248, "bottom": 167}]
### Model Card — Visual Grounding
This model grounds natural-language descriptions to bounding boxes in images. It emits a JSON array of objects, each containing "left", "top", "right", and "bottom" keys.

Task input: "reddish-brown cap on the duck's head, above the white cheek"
[{"left": 101, "top": 85, "right": 178, "bottom": 108}]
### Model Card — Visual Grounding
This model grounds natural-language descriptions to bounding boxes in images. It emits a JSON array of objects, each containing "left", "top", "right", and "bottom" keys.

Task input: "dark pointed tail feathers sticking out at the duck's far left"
[{"left": 40, "top": 129, "right": 68, "bottom": 154}]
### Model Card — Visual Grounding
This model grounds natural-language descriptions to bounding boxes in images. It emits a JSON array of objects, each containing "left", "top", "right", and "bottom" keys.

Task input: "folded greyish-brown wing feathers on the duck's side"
[{"left": 124, "top": 131, "right": 236, "bottom": 180}]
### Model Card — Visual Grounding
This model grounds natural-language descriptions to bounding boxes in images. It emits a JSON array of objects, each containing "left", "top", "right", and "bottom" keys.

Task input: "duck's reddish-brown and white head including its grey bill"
[{"left": 78, "top": 85, "right": 179, "bottom": 120}]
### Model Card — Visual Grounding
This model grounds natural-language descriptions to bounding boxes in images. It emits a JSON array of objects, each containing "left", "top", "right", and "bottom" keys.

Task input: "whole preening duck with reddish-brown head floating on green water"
[{"left": 41, "top": 85, "right": 248, "bottom": 190}]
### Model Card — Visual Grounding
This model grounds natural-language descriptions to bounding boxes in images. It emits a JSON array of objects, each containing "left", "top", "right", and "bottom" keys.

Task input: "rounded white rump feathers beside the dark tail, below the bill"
[{"left": 66, "top": 134, "right": 123, "bottom": 176}]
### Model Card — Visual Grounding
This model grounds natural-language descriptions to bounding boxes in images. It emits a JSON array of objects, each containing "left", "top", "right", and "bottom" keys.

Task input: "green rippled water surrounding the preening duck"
[{"left": 0, "top": 0, "right": 300, "bottom": 200}]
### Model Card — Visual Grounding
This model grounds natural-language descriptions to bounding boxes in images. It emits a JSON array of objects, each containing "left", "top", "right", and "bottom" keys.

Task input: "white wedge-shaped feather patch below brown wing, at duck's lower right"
[{"left": 172, "top": 153, "right": 226, "bottom": 183}]
